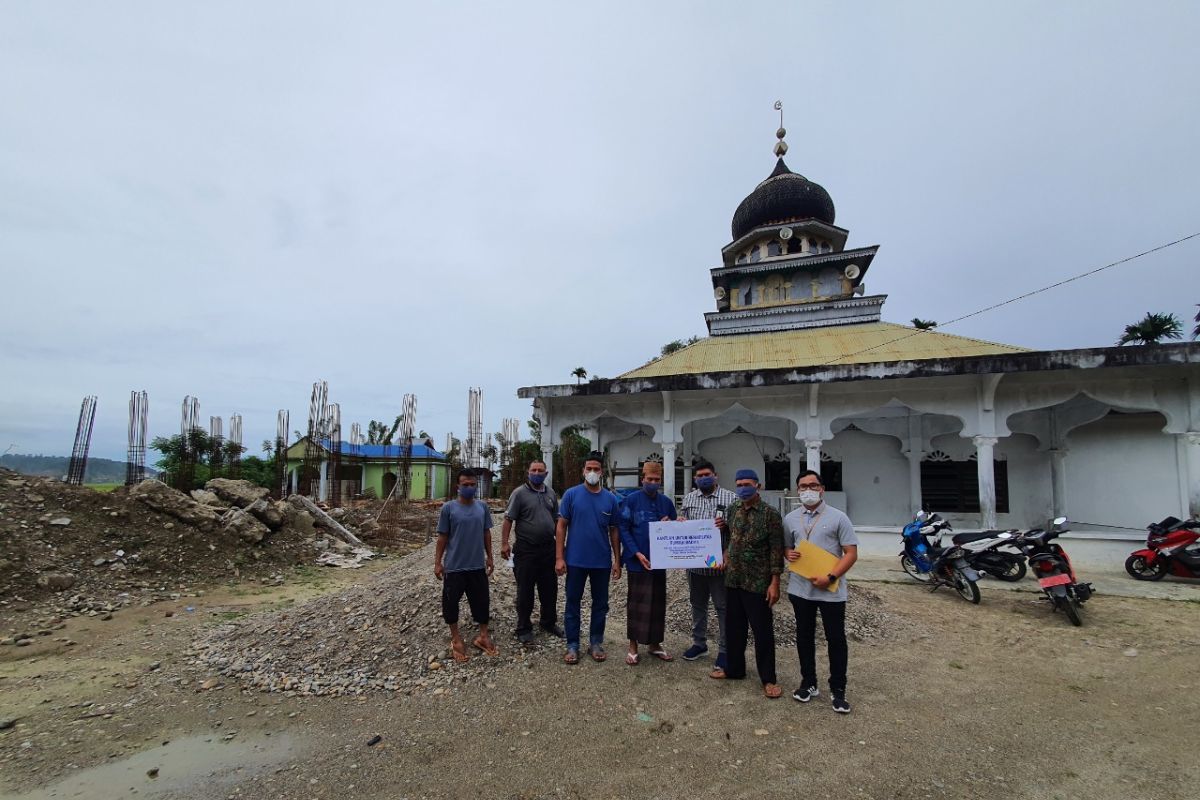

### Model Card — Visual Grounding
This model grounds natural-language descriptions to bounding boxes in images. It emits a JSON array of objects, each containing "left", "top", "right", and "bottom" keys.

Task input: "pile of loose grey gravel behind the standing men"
[{"left": 190, "top": 545, "right": 896, "bottom": 696}]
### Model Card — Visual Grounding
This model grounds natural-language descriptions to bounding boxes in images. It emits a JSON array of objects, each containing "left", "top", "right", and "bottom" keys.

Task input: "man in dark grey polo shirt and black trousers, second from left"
[{"left": 500, "top": 461, "right": 563, "bottom": 644}]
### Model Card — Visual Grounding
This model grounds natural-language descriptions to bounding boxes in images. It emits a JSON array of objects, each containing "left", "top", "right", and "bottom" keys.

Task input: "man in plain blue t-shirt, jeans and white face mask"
[{"left": 554, "top": 451, "right": 620, "bottom": 664}]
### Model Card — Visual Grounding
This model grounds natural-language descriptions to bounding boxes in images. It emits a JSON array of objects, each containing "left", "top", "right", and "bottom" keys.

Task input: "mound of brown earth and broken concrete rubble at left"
[{"left": 0, "top": 470, "right": 376, "bottom": 616}]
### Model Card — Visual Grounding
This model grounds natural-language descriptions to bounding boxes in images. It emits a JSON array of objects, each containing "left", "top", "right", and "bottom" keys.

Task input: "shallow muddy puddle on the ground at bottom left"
[{"left": 0, "top": 733, "right": 300, "bottom": 800}]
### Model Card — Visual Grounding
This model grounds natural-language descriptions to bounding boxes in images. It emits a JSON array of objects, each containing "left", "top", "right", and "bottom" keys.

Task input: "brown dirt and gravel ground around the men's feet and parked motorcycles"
[{"left": 0, "top": 552, "right": 1200, "bottom": 800}]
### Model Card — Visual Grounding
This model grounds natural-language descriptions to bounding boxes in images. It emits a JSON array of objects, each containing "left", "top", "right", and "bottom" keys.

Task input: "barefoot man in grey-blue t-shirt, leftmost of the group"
[{"left": 433, "top": 469, "right": 500, "bottom": 663}]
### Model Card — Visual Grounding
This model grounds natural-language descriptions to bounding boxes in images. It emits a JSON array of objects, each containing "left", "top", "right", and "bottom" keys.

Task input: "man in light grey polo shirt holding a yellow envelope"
[{"left": 784, "top": 470, "right": 858, "bottom": 714}]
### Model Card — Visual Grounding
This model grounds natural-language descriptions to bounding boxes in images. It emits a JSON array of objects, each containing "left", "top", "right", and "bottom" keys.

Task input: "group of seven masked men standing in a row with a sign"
[{"left": 433, "top": 452, "right": 858, "bottom": 714}]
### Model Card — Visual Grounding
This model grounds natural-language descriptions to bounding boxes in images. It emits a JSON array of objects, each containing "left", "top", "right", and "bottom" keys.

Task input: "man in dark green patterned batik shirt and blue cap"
[{"left": 712, "top": 469, "right": 784, "bottom": 699}]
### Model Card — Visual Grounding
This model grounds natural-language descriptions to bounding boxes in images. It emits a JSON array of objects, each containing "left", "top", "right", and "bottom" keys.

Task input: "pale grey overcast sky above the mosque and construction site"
[{"left": 0, "top": 0, "right": 1200, "bottom": 462}]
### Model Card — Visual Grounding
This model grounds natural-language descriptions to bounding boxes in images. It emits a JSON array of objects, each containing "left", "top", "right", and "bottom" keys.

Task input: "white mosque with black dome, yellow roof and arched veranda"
[{"left": 518, "top": 122, "right": 1200, "bottom": 544}]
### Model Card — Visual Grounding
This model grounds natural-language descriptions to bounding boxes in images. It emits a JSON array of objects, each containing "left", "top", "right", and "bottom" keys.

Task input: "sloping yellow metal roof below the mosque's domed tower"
[{"left": 620, "top": 323, "right": 1027, "bottom": 379}]
